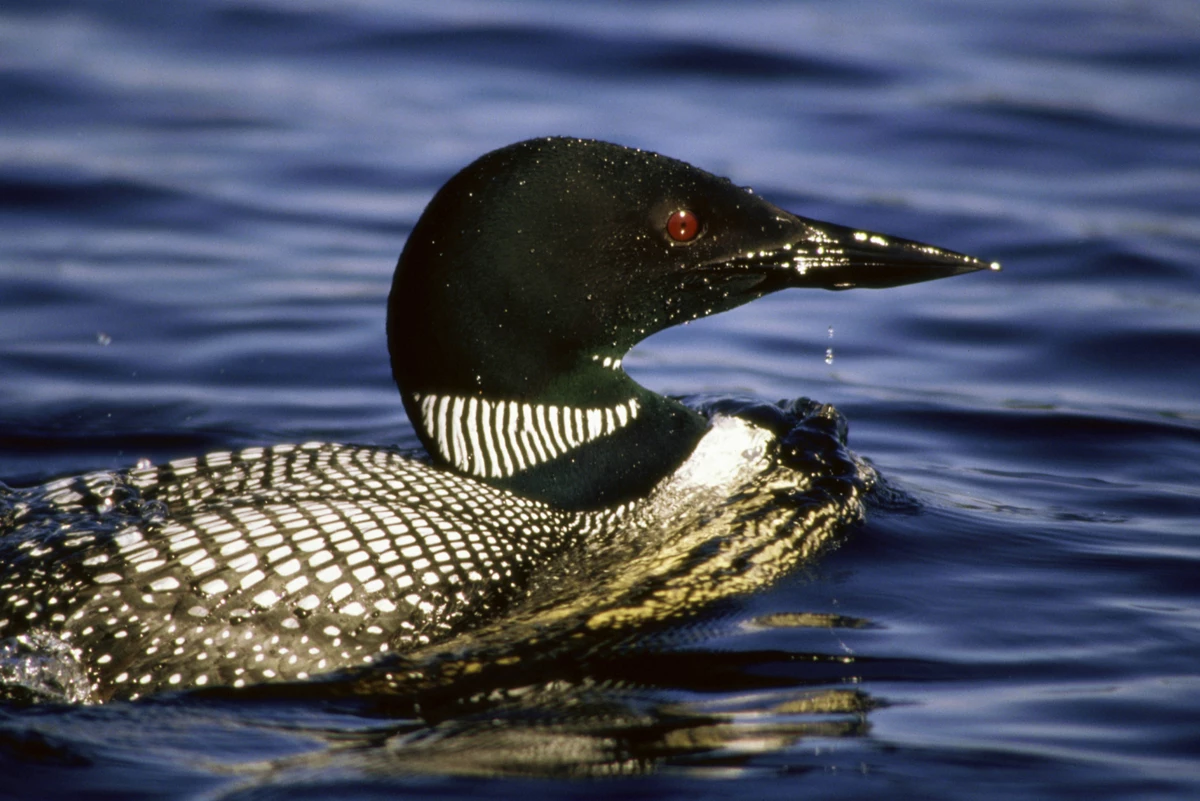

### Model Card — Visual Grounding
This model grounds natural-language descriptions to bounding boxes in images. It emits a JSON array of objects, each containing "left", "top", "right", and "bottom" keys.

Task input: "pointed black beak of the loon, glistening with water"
[{"left": 736, "top": 215, "right": 1000, "bottom": 289}]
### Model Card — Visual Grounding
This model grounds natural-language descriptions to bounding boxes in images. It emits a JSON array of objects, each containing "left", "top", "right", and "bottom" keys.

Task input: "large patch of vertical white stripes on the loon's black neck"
[{"left": 413, "top": 395, "right": 638, "bottom": 478}]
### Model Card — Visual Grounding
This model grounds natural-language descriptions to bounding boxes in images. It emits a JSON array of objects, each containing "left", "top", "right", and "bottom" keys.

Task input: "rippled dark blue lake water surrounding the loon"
[{"left": 0, "top": 0, "right": 1200, "bottom": 799}]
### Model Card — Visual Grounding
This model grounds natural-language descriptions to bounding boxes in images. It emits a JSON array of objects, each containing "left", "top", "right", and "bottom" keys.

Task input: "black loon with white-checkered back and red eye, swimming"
[{"left": 0, "top": 138, "right": 998, "bottom": 701}]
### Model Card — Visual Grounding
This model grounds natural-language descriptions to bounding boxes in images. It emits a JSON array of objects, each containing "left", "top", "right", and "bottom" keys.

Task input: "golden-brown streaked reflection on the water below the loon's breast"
[{"left": 247, "top": 681, "right": 871, "bottom": 785}]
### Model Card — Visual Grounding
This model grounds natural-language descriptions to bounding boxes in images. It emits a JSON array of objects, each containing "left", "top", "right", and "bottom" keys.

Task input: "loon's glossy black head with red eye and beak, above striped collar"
[{"left": 388, "top": 138, "right": 989, "bottom": 500}]
